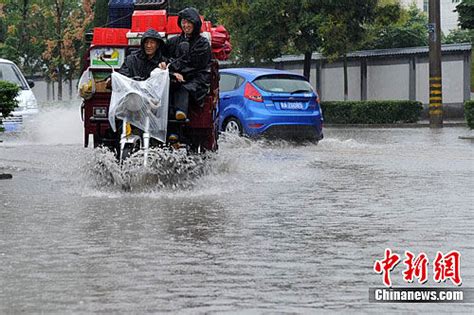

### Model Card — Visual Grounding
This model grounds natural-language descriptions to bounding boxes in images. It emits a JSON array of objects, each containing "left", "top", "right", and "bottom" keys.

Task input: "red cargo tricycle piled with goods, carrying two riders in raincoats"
[{"left": 79, "top": 8, "right": 223, "bottom": 163}]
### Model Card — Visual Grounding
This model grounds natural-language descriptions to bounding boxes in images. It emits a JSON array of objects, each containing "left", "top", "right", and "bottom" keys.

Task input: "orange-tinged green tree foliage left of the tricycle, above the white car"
[{"left": 0, "top": 0, "right": 95, "bottom": 98}]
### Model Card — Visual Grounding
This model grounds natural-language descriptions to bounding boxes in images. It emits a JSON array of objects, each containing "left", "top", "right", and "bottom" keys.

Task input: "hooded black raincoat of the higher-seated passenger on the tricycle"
[{"left": 165, "top": 8, "right": 211, "bottom": 103}]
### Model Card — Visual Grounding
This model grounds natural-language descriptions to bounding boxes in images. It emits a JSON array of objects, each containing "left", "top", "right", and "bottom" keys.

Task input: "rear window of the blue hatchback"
[{"left": 253, "top": 74, "right": 313, "bottom": 93}]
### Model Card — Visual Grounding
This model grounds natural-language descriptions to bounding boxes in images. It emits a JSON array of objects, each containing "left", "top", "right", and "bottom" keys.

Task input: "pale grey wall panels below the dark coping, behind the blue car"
[{"left": 280, "top": 56, "right": 465, "bottom": 104}]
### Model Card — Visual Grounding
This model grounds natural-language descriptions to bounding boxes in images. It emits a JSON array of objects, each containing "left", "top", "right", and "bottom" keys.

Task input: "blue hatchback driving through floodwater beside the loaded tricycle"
[{"left": 219, "top": 68, "right": 323, "bottom": 141}]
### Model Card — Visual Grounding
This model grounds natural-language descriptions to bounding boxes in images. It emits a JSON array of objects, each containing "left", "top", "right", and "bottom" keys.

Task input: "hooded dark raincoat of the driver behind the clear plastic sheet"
[{"left": 119, "top": 29, "right": 165, "bottom": 79}]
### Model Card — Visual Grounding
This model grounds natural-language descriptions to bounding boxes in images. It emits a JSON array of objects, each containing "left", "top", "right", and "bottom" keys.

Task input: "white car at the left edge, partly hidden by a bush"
[{"left": 0, "top": 58, "right": 38, "bottom": 131}]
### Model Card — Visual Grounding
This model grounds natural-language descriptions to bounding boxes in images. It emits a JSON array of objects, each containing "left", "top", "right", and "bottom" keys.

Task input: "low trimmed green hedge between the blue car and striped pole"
[{"left": 321, "top": 101, "right": 423, "bottom": 124}]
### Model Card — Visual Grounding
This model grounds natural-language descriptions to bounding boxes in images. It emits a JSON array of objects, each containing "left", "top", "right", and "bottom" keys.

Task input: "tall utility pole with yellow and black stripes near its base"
[{"left": 428, "top": 0, "right": 443, "bottom": 128}]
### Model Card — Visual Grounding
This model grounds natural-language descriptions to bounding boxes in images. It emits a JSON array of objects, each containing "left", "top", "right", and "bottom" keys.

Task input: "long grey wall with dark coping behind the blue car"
[{"left": 223, "top": 44, "right": 472, "bottom": 118}]
